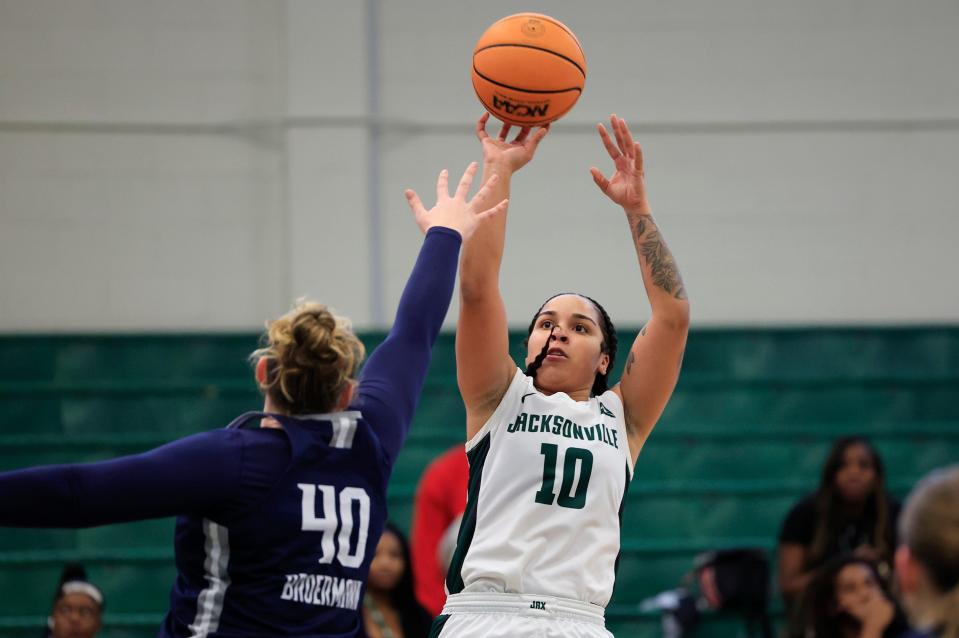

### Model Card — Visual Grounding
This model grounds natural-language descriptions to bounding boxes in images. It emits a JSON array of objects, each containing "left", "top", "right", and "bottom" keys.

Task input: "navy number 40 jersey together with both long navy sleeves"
[{"left": 0, "top": 228, "right": 460, "bottom": 638}]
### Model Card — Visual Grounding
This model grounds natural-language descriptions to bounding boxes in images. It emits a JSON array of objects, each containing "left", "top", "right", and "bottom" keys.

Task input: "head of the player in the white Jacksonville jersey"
[{"left": 526, "top": 295, "right": 609, "bottom": 392}]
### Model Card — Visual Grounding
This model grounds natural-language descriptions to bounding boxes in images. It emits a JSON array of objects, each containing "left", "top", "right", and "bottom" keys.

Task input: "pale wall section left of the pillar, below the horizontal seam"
[{"left": 0, "top": 133, "right": 282, "bottom": 331}]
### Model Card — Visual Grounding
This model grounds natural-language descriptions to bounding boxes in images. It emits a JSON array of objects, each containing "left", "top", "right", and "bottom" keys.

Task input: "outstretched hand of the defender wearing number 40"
[{"left": 406, "top": 162, "right": 508, "bottom": 241}]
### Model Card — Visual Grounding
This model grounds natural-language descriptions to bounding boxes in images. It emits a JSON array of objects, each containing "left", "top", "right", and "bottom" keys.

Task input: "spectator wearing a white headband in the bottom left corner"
[{"left": 44, "top": 563, "right": 103, "bottom": 638}]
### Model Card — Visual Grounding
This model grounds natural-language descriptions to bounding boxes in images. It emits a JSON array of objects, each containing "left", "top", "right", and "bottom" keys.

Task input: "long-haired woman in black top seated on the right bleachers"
[{"left": 779, "top": 436, "right": 899, "bottom": 609}]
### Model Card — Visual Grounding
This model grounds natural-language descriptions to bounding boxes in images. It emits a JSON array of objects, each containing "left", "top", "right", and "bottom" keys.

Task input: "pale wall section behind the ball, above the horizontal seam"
[{"left": 383, "top": 0, "right": 959, "bottom": 122}]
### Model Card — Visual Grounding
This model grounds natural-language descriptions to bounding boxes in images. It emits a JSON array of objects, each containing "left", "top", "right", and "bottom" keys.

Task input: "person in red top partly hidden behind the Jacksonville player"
[{"left": 412, "top": 445, "right": 469, "bottom": 616}]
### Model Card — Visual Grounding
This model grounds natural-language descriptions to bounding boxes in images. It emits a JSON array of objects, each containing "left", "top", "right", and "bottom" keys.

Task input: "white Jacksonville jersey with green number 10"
[{"left": 446, "top": 369, "right": 633, "bottom": 607}]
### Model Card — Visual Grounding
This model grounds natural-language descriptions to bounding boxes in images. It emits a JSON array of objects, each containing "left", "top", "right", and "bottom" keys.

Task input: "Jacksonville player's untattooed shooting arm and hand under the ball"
[{"left": 456, "top": 113, "right": 549, "bottom": 438}]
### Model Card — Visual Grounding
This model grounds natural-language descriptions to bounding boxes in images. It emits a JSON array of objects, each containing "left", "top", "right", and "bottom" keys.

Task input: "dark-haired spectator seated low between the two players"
[{"left": 363, "top": 522, "right": 433, "bottom": 638}]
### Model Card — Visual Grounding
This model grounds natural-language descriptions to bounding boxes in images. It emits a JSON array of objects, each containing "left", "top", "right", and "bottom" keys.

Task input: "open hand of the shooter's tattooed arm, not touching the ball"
[{"left": 589, "top": 115, "right": 651, "bottom": 215}]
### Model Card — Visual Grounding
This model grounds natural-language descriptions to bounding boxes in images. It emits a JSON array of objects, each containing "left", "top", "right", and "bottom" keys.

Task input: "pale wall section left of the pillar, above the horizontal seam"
[{"left": 0, "top": 0, "right": 285, "bottom": 123}]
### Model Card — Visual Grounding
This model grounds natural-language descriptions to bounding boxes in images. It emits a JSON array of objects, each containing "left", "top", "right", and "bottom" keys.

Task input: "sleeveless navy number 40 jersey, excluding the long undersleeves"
[{"left": 160, "top": 412, "right": 391, "bottom": 638}]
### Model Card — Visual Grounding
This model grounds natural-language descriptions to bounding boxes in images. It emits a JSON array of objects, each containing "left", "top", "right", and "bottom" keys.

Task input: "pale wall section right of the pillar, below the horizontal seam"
[{"left": 386, "top": 125, "right": 959, "bottom": 325}]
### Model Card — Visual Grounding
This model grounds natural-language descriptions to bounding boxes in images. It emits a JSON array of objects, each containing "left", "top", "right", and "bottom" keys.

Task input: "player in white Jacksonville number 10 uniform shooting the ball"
[{"left": 433, "top": 116, "right": 689, "bottom": 638}]
